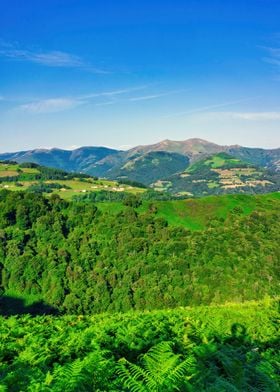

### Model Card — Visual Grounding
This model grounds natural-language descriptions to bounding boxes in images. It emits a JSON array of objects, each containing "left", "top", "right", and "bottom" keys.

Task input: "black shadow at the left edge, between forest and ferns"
[{"left": 0, "top": 295, "right": 58, "bottom": 316}]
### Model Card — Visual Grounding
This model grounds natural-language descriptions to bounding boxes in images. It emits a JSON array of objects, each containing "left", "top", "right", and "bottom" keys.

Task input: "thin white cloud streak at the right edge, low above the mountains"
[{"left": 207, "top": 112, "right": 280, "bottom": 121}]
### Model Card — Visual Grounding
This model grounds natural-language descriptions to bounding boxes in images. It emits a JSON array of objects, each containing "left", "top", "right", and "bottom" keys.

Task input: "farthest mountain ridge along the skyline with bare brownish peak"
[{"left": 0, "top": 138, "right": 280, "bottom": 178}]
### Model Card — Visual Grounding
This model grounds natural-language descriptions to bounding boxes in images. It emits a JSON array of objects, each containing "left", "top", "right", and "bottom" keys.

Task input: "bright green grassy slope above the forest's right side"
[{"left": 94, "top": 192, "right": 280, "bottom": 230}]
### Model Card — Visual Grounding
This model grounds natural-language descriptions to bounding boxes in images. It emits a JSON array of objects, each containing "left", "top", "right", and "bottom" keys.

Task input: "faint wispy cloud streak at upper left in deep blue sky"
[{"left": 0, "top": 41, "right": 108, "bottom": 73}]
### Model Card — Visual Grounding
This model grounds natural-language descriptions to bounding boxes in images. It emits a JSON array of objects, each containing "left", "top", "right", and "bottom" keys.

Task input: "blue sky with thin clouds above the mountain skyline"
[{"left": 0, "top": 0, "right": 280, "bottom": 152}]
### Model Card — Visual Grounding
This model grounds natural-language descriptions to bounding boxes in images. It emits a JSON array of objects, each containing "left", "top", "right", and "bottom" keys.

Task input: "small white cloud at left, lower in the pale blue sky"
[{"left": 17, "top": 98, "right": 83, "bottom": 114}]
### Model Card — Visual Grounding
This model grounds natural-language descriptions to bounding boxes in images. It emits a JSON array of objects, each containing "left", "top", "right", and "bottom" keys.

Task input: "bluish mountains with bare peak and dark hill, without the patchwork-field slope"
[{"left": 0, "top": 138, "right": 280, "bottom": 190}]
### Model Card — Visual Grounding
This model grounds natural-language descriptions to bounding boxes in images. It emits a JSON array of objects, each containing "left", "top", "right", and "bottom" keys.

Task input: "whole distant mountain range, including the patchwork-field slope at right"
[{"left": 0, "top": 138, "right": 280, "bottom": 193}]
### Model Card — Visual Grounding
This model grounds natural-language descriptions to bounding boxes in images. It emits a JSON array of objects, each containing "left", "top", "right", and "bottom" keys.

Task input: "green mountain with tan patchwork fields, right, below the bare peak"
[{"left": 155, "top": 152, "right": 280, "bottom": 196}]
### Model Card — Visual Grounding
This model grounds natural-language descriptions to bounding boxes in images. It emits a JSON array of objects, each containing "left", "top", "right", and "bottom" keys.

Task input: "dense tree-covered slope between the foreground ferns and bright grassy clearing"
[{"left": 0, "top": 191, "right": 280, "bottom": 313}]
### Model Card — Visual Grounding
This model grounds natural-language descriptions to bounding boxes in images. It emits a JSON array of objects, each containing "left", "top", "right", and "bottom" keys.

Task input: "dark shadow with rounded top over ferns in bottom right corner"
[{"left": 186, "top": 323, "right": 279, "bottom": 392}]
